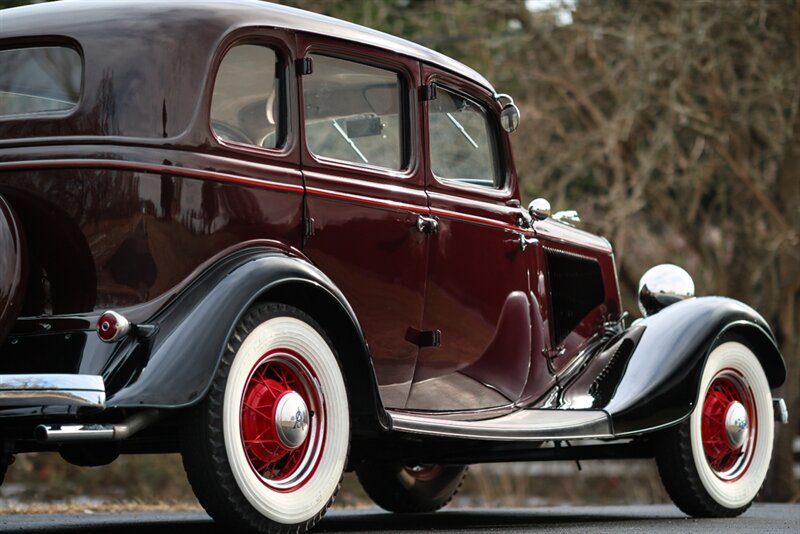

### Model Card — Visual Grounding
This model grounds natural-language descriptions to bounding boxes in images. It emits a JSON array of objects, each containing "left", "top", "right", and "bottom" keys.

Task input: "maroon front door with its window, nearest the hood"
[{"left": 406, "top": 66, "right": 549, "bottom": 411}]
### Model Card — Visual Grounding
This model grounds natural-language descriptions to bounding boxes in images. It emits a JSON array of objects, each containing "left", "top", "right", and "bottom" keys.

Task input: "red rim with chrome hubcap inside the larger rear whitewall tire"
[{"left": 240, "top": 349, "right": 325, "bottom": 492}]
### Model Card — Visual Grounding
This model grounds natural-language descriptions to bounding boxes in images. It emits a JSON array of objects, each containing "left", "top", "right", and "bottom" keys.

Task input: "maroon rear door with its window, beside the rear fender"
[{"left": 298, "top": 36, "right": 429, "bottom": 408}]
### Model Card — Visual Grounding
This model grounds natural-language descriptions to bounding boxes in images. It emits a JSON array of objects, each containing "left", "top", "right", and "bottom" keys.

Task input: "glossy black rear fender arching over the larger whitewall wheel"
[{"left": 105, "top": 248, "right": 386, "bottom": 434}]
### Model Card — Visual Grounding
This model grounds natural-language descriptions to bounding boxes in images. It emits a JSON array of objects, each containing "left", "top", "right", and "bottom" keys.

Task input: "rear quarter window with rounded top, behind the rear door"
[{"left": 211, "top": 44, "right": 284, "bottom": 148}]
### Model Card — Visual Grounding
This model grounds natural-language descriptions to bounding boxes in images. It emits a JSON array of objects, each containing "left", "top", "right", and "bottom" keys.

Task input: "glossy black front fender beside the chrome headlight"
[{"left": 602, "top": 297, "right": 786, "bottom": 436}]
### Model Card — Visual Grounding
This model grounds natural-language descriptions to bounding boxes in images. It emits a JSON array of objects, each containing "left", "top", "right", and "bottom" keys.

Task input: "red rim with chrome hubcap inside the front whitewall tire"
[{"left": 701, "top": 369, "right": 758, "bottom": 482}]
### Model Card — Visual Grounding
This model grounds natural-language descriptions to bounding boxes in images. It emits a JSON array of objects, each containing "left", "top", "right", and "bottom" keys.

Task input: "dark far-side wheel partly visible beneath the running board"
[{"left": 356, "top": 463, "right": 468, "bottom": 514}]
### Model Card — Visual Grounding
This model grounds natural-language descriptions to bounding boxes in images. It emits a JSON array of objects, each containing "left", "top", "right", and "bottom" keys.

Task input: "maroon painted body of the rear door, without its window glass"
[{"left": 298, "top": 35, "right": 428, "bottom": 408}]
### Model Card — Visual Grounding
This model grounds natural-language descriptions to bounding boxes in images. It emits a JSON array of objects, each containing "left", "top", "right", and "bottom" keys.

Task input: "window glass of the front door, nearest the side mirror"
[{"left": 428, "top": 86, "right": 502, "bottom": 188}]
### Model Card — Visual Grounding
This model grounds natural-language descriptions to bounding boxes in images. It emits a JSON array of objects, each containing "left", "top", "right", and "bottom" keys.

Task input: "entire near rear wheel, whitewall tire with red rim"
[{"left": 182, "top": 304, "right": 350, "bottom": 533}]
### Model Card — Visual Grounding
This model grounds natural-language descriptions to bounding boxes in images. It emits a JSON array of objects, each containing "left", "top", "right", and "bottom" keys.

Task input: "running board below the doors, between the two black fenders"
[{"left": 387, "top": 410, "right": 614, "bottom": 441}]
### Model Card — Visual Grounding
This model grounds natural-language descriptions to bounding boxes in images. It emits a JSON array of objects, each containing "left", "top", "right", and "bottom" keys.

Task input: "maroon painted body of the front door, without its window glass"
[{"left": 406, "top": 66, "right": 531, "bottom": 410}]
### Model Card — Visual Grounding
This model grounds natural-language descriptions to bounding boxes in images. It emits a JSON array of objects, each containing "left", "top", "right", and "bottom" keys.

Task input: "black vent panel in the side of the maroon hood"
[{"left": 545, "top": 248, "right": 605, "bottom": 346}]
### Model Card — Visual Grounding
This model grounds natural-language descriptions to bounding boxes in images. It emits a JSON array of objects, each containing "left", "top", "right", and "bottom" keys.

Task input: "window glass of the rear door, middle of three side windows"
[{"left": 303, "top": 55, "right": 406, "bottom": 170}]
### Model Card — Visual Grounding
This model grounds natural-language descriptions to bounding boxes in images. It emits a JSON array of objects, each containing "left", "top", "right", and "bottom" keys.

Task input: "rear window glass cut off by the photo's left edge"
[{"left": 0, "top": 46, "right": 82, "bottom": 117}]
